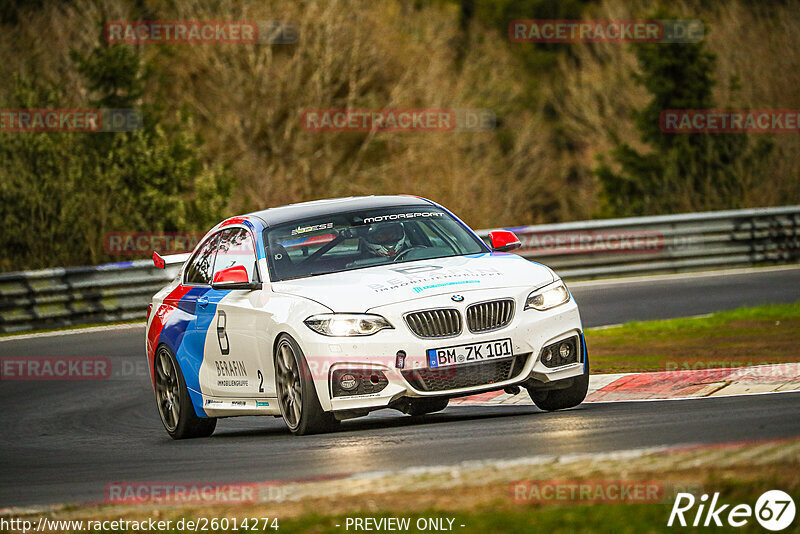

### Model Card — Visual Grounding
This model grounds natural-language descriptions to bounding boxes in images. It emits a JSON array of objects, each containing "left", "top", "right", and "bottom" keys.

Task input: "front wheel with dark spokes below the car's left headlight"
[{"left": 275, "top": 334, "right": 338, "bottom": 436}]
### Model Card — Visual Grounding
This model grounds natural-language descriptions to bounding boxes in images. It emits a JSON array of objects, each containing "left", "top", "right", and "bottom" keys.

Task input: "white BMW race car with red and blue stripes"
[{"left": 146, "top": 196, "right": 589, "bottom": 439}]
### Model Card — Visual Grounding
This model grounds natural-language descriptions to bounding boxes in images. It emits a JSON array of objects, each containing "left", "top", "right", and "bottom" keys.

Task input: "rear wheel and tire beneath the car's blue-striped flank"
[{"left": 153, "top": 345, "right": 217, "bottom": 439}]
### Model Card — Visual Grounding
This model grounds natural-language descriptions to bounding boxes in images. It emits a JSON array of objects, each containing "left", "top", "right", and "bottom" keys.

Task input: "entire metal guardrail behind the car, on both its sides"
[{"left": 0, "top": 206, "right": 800, "bottom": 332}]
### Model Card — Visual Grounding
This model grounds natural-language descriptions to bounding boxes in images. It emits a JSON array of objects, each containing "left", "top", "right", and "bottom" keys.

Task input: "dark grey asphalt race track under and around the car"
[{"left": 0, "top": 268, "right": 800, "bottom": 508}]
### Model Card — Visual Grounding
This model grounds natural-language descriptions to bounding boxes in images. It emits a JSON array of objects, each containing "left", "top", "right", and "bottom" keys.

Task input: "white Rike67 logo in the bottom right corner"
[{"left": 667, "top": 490, "right": 796, "bottom": 532}]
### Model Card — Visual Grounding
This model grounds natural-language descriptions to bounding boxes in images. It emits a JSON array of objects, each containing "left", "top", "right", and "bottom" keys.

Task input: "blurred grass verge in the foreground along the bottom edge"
[{"left": 3, "top": 439, "right": 800, "bottom": 534}]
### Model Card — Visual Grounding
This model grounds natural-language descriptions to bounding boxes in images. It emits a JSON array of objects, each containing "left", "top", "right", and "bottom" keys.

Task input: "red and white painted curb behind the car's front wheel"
[{"left": 450, "top": 363, "right": 800, "bottom": 406}]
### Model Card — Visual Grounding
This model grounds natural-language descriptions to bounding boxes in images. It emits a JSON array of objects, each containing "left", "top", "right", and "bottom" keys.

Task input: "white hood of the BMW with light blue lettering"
[{"left": 272, "top": 252, "right": 556, "bottom": 313}]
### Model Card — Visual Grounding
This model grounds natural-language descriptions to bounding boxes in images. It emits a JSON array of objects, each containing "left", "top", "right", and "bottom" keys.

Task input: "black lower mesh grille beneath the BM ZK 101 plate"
[{"left": 403, "top": 354, "right": 529, "bottom": 391}]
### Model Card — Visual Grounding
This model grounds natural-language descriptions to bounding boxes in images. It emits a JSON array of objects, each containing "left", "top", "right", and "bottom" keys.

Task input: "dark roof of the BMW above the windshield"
[{"left": 247, "top": 195, "right": 435, "bottom": 226}]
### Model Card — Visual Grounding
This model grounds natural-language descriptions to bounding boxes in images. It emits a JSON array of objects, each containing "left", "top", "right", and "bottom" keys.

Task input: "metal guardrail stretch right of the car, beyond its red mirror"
[{"left": 478, "top": 206, "right": 800, "bottom": 279}]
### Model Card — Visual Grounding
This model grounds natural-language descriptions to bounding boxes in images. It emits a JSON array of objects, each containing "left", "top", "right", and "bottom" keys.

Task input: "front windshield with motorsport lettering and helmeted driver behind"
[{"left": 264, "top": 206, "right": 487, "bottom": 281}]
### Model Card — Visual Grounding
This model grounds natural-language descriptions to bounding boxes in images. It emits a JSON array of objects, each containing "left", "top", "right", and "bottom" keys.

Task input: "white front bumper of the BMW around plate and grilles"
[{"left": 302, "top": 288, "right": 585, "bottom": 412}]
